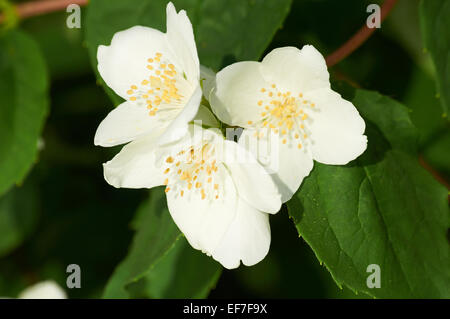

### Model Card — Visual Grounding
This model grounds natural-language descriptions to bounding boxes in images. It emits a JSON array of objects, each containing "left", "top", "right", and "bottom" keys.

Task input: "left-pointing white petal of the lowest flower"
[{"left": 103, "top": 135, "right": 165, "bottom": 188}]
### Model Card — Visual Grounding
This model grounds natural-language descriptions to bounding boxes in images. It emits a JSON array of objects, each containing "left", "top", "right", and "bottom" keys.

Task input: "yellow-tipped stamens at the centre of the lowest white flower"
[{"left": 163, "top": 143, "right": 222, "bottom": 200}]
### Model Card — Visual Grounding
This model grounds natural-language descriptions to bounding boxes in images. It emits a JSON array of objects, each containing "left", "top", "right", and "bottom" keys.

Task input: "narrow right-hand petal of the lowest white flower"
[{"left": 225, "top": 140, "right": 281, "bottom": 214}]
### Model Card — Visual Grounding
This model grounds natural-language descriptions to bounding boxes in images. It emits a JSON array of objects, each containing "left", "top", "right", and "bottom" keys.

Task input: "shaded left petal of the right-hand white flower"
[{"left": 210, "top": 62, "right": 268, "bottom": 127}]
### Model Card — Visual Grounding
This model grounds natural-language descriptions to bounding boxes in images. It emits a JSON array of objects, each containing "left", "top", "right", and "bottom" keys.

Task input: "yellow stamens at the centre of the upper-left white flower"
[{"left": 127, "top": 53, "right": 186, "bottom": 116}]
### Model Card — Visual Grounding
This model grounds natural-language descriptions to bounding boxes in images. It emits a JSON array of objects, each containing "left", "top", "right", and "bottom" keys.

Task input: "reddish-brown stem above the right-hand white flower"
[{"left": 326, "top": 0, "right": 397, "bottom": 67}]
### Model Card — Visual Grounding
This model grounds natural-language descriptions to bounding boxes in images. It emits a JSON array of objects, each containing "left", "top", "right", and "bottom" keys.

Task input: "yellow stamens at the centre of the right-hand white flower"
[{"left": 248, "top": 84, "right": 316, "bottom": 149}]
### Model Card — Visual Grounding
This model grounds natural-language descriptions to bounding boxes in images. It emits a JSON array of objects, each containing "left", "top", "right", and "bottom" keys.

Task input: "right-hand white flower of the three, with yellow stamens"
[{"left": 210, "top": 45, "right": 367, "bottom": 202}]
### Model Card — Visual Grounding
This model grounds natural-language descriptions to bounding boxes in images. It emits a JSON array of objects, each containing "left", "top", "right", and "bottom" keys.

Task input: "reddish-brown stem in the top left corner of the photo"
[{"left": 0, "top": 0, "right": 89, "bottom": 23}]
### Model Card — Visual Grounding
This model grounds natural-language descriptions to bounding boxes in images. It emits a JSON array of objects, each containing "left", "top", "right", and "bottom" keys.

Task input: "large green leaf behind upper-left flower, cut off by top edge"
[{"left": 86, "top": 0, "right": 291, "bottom": 104}]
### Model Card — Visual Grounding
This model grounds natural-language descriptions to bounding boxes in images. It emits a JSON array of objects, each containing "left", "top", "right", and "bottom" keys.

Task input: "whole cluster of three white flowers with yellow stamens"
[{"left": 95, "top": 3, "right": 367, "bottom": 268}]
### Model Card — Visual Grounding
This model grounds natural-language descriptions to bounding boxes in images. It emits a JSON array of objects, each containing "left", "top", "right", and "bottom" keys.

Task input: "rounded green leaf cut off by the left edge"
[{"left": 0, "top": 31, "right": 48, "bottom": 194}]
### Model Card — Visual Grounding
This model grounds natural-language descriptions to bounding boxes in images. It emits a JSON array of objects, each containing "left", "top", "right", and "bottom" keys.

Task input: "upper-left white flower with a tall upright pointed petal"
[{"left": 94, "top": 2, "right": 202, "bottom": 146}]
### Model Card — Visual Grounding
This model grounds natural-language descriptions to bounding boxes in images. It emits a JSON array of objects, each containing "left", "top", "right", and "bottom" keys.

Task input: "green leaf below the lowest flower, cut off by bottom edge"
[{"left": 103, "top": 188, "right": 221, "bottom": 298}]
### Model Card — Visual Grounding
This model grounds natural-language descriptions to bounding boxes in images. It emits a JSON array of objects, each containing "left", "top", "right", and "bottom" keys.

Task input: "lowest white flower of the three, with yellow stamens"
[{"left": 104, "top": 125, "right": 281, "bottom": 268}]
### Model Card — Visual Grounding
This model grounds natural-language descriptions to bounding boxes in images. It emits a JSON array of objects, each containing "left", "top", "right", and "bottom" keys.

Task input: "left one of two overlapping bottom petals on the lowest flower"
[{"left": 167, "top": 170, "right": 238, "bottom": 255}]
